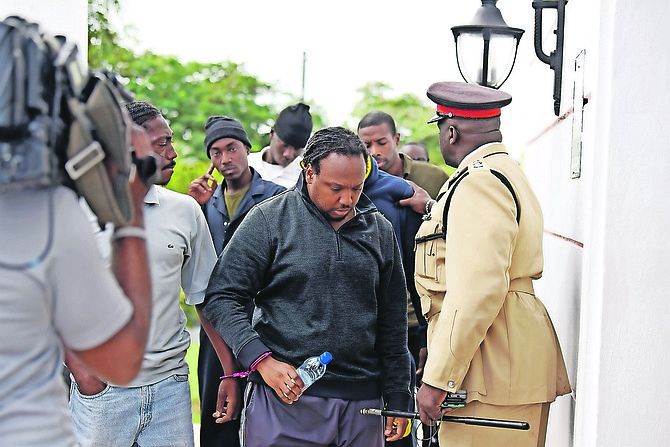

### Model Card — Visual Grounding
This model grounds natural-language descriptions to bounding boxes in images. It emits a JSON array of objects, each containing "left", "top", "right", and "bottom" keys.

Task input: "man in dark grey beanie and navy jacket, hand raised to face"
[{"left": 188, "top": 116, "right": 285, "bottom": 447}]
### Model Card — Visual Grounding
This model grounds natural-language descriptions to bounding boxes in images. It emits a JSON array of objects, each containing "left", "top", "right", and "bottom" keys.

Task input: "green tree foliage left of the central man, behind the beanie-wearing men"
[{"left": 88, "top": 0, "right": 322, "bottom": 192}]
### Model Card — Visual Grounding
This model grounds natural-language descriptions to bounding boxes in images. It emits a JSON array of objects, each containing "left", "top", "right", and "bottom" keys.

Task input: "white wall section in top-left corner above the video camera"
[{"left": 0, "top": 0, "right": 88, "bottom": 67}]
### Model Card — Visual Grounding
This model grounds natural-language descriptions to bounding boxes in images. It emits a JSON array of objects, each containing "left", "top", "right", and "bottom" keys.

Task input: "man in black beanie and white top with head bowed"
[{"left": 249, "top": 103, "right": 313, "bottom": 188}]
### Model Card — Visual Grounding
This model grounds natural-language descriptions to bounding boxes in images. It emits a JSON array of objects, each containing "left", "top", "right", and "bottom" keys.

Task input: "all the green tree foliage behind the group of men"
[{"left": 88, "top": 0, "right": 444, "bottom": 192}]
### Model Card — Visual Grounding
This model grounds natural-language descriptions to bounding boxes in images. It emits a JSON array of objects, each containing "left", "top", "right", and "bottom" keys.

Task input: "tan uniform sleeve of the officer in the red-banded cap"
[{"left": 423, "top": 172, "right": 518, "bottom": 391}]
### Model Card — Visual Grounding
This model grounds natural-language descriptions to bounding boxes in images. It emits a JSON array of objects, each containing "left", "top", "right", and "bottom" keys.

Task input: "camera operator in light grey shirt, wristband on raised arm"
[{"left": 0, "top": 126, "right": 152, "bottom": 447}]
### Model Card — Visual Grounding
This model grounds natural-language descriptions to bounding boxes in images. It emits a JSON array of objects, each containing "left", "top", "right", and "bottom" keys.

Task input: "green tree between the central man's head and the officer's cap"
[{"left": 348, "top": 82, "right": 453, "bottom": 172}]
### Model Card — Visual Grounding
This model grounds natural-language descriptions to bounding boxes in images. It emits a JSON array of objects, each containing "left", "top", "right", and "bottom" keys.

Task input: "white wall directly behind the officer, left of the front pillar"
[{"left": 498, "top": 1, "right": 598, "bottom": 447}]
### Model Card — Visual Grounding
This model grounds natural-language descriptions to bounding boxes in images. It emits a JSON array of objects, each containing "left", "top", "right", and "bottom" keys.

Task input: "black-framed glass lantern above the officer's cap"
[{"left": 451, "top": 0, "right": 528, "bottom": 89}]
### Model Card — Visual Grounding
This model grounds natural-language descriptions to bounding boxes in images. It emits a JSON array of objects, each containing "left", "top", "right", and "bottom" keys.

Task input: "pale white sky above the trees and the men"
[{"left": 113, "top": 0, "right": 532, "bottom": 125}]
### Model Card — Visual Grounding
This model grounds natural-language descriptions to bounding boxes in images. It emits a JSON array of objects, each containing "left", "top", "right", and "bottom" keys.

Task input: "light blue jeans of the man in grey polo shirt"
[{"left": 70, "top": 374, "right": 194, "bottom": 447}]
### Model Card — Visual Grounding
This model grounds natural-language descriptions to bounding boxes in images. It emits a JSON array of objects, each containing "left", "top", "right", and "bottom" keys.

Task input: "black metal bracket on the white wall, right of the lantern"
[{"left": 533, "top": 0, "right": 568, "bottom": 116}]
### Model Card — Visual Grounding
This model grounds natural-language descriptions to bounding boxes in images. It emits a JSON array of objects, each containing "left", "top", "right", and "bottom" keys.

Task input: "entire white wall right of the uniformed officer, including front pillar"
[{"left": 510, "top": 0, "right": 670, "bottom": 447}]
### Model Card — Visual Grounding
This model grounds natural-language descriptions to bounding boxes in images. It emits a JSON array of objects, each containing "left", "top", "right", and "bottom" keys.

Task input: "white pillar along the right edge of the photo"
[{"left": 576, "top": 0, "right": 670, "bottom": 446}]
